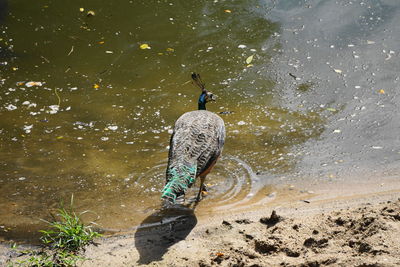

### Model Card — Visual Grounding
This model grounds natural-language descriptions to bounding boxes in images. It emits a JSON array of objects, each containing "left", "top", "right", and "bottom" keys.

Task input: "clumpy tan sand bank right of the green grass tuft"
[{"left": 83, "top": 194, "right": 400, "bottom": 267}]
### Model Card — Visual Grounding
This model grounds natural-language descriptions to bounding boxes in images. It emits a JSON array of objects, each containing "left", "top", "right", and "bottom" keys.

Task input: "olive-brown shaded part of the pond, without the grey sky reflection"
[{"left": 0, "top": 1, "right": 322, "bottom": 243}]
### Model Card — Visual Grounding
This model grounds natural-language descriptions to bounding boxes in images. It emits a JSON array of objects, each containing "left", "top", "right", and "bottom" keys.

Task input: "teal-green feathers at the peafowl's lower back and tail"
[{"left": 161, "top": 165, "right": 197, "bottom": 203}]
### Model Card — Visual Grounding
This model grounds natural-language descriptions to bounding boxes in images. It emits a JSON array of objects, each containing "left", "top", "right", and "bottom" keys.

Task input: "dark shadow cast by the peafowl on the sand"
[{"left": 135, "top": 205, "right": 197, "bottom": 264}]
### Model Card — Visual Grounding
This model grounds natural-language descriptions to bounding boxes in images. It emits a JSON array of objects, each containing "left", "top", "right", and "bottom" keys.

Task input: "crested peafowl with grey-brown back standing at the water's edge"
[{"left": 161, "top": 73, "right": 225, "bottom": 203}]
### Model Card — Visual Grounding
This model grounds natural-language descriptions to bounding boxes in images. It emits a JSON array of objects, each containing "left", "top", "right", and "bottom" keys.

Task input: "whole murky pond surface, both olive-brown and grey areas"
[{"left": 0, "top": 0, "right": 400, "bottom": 243}]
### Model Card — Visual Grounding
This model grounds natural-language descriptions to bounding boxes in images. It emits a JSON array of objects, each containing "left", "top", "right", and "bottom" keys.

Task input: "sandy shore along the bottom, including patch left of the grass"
[{"left": 0, "top": 180, "right": 400, "bottom": 267}]
